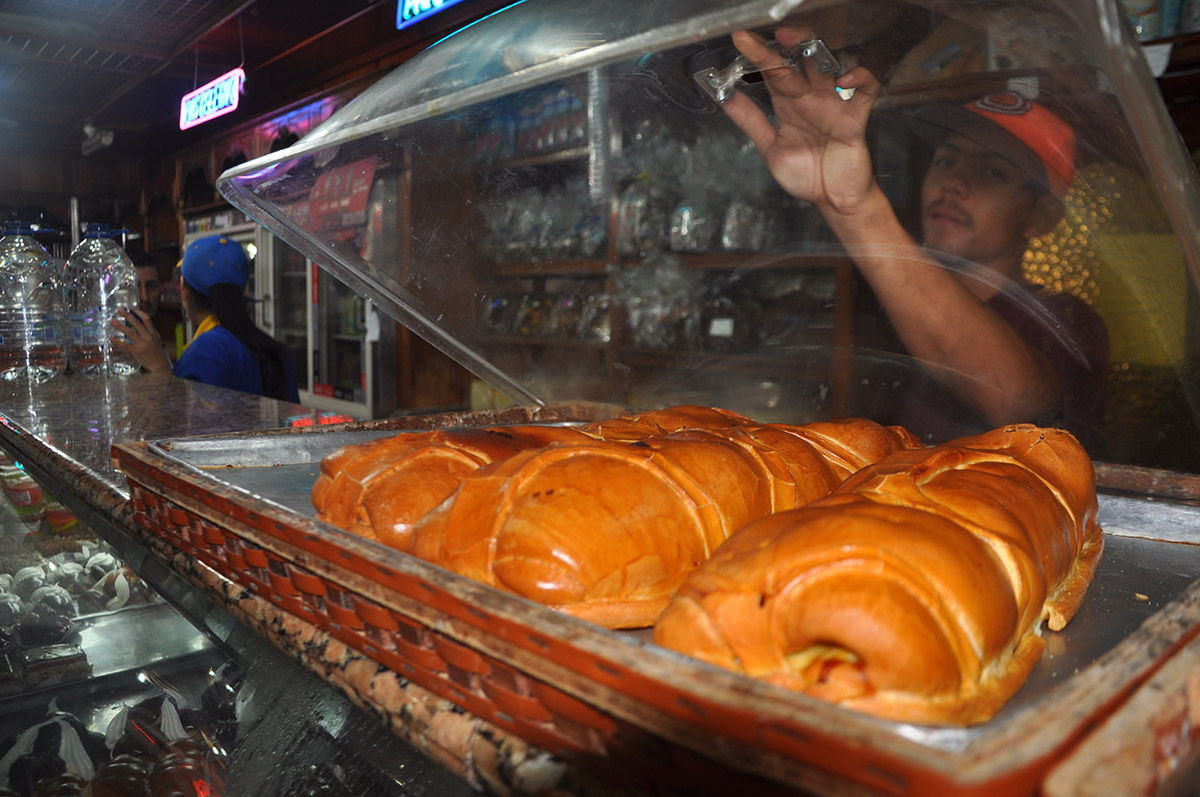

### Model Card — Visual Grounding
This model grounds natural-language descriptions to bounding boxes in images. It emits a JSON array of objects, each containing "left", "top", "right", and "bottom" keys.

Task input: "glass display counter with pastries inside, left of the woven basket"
[{"left": 0, "top": 377, "right": 473, "bottom": 797}]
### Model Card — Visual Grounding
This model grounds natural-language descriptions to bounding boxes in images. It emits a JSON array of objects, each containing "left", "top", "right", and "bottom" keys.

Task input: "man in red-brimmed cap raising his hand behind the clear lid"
[{"left": 724, "top": 28, "right": 1108, "bottom": 442}]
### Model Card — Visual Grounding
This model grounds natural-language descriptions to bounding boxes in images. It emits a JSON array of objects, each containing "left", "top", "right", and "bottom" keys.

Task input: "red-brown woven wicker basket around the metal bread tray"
[{"left": 113, "top": 415, "right": 1200, "bottom": 795}]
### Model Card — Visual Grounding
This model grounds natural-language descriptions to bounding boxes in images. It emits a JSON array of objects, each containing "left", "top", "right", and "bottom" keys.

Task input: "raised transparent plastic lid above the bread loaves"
[{"left": 218, "top": 0, "right": 1200, "bottom": 472}]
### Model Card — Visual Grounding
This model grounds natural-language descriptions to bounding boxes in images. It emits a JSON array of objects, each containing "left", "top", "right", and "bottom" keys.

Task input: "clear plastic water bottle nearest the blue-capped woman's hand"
[{"left": 62, "top": 223, "right": 138, "bottom": 376}]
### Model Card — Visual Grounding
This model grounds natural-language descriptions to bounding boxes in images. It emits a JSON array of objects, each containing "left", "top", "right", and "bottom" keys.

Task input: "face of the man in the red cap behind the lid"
[{"left": 922, "top": 134, "right": 1044, "bottom": 271}]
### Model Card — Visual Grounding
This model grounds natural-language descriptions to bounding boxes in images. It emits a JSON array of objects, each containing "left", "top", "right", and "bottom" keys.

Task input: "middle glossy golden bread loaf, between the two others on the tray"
[{"left": 408, "top": 419, "right": 919, "bottom": 628}]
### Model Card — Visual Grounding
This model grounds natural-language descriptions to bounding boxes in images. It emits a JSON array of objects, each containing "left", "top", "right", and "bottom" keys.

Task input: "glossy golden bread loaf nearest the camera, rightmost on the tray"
[{"left": 654, "top": 425, "right": 1103, "bottom": 725}]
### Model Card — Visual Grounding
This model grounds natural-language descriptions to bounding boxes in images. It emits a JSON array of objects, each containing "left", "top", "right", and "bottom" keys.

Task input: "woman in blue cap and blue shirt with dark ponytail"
[{"left": 113, "top": 235, "right": 300, "bottom": 402}]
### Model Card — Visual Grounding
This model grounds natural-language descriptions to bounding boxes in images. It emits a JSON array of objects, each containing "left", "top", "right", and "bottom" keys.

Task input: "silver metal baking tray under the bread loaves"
[{"left": 150, "top": 430, "right": 1200, "bottom": 751}]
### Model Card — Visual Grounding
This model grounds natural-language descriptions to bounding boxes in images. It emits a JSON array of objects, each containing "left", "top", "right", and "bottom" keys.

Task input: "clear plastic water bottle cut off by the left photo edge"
[{"left": 0, "top": 221, "right": 66, "bottom": 382}]
